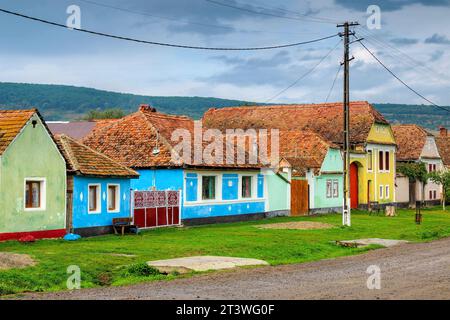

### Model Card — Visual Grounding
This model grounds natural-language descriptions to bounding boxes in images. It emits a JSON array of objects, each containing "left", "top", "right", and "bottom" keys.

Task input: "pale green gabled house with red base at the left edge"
[{"left": 0, "top": 109, "right": 66, "bottom": 240}]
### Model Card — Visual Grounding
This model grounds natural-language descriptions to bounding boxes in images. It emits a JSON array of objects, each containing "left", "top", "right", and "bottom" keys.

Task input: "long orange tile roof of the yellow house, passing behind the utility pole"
[{"left": 203, "top": 101, "right": 389, "bottom": 144}]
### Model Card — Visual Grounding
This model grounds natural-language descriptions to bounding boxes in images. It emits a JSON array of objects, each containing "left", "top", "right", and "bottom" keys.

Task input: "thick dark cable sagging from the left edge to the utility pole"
[{"left": 0, "top": 8, "right": 337, "bottom": 51}]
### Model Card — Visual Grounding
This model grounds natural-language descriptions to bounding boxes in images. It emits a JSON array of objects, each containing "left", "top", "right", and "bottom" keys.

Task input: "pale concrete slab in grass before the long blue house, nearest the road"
[{"left": 147, "top": 256, "right": 268, "bottom": 273}]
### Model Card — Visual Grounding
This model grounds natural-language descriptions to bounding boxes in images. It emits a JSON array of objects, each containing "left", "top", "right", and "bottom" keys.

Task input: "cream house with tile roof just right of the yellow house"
[{"left": 392, "top": 124, "right": 443, "bottom": 205}]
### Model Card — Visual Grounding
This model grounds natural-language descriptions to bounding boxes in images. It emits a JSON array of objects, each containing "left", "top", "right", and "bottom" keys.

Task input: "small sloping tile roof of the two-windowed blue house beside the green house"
[{"left": 55, "top": 135, "right": 139, "bottom": 178}]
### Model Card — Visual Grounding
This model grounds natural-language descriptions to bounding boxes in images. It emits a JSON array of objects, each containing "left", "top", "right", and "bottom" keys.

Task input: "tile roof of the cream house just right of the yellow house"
[{"left": 392, "top": 124, "right": 431, "bottom": 161}]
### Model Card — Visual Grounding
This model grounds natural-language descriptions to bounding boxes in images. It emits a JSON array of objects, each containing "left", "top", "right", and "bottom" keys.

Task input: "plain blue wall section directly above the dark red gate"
[{"left": 131, "top": 169, "right": 183, "bottom": 191}]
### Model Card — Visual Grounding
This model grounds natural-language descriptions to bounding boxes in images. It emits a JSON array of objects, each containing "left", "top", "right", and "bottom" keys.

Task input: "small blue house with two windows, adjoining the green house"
[{"left": 55, "top": 135, "right": 139, "bottom": 236}]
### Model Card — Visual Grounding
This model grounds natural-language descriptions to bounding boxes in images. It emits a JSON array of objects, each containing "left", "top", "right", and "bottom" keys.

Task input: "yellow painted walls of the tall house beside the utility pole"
[{"left": 350, "top": 124, "right": 395, "bottom": 204}]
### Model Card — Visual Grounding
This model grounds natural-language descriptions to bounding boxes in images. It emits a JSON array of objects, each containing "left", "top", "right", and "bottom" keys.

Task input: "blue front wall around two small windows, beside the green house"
[{"left": 72, "top": 176, "right": 130, "bottom": 229}]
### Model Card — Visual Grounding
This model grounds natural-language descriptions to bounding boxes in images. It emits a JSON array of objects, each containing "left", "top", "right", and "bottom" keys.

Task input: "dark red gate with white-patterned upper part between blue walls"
[{"left": 132, "top": 191, "right": 181, "bottom": 228}]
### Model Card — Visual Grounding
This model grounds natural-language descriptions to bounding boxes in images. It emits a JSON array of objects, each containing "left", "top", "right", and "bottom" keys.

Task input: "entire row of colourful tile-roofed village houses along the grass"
[{"left": 0, "top": 101, "right": 450, "bottom": 240}]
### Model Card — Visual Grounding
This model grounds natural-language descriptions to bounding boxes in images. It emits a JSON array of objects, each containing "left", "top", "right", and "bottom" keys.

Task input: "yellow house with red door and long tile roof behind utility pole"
[{"left": 203, "top": 101, "right": 396, "bottom": 208}]
